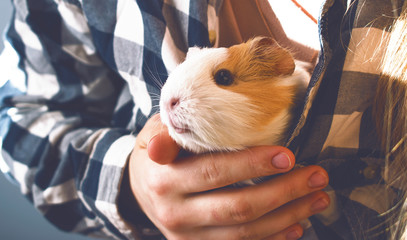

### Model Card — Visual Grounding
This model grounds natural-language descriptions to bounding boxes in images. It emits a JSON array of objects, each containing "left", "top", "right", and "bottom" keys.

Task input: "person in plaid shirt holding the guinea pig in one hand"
[{"left": 0, "top": 0, "right": 407, "bottom": 240}]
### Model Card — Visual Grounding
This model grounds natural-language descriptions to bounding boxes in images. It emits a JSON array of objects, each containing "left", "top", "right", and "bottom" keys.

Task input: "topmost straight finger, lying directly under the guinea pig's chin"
[{"left": 172, "top": 146, "right": 295, "bottom": 193}]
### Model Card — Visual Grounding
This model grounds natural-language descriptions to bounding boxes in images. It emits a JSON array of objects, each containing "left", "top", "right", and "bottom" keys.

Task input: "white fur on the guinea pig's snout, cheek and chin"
[{"left": 160, "top": 48, "right": 308, "bottom": 153}]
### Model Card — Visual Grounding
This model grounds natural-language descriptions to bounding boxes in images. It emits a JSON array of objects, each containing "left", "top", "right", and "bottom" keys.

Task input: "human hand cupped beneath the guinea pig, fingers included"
[{"left": 129, "top": 115, "right": 329, "bottom": 239}]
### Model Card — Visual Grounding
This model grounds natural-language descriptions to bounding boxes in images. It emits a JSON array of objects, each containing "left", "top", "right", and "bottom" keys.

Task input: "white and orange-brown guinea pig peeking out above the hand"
[{"left": 160, "top": 37, "right": 310, "bottom": 153}]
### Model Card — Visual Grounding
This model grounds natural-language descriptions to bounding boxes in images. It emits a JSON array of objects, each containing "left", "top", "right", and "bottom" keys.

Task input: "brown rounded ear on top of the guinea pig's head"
[{"left": 250, "top": 37, "right": 295, "bottom": 76}]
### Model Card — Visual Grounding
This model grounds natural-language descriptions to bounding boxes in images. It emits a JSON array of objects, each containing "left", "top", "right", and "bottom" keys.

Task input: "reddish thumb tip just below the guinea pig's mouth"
[{"left": 147, "top": 115, "right": 180, "bottom": 164}]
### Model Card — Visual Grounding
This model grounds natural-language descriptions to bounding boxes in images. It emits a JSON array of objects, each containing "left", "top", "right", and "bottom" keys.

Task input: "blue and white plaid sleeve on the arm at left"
[{"left": 0, "top": 1, "right": 139, "bottom": 239}]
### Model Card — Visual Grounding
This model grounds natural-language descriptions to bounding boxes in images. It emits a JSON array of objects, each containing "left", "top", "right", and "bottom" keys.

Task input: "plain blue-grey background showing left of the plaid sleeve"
[{"left": 0, "top": 0, "right": 91, "bottom": 240}]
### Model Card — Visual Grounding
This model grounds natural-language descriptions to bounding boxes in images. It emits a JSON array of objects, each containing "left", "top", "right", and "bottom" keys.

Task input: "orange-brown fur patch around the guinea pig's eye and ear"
[{"left": 213, "top": 37, "right": 296, "bottom": 130}]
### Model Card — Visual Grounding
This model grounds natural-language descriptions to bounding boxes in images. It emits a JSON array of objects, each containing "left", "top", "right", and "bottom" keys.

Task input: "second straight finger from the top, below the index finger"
[{"left": 164, "top": 166, "right": 328, "bottom": 227}]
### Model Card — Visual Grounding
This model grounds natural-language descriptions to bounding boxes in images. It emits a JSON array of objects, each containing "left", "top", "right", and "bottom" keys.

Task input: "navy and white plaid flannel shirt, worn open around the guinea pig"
[{"left": 0, "top": 0, "right": 402, "bottom": 240}]
